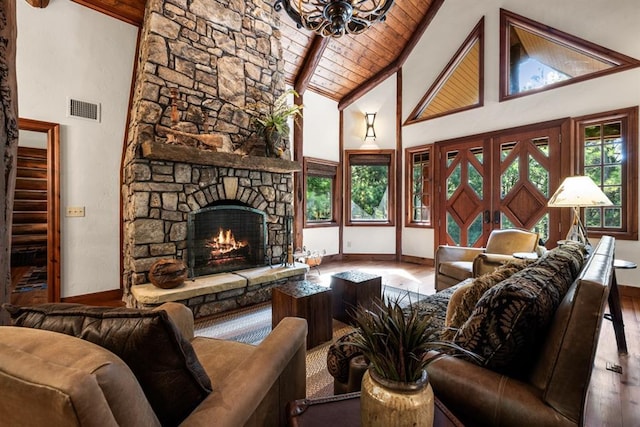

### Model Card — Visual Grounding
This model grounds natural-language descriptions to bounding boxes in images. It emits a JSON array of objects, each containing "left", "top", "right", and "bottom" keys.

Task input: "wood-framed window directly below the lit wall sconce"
[{"left": 345, "top": 150, "right": 395, "bottom": 225}]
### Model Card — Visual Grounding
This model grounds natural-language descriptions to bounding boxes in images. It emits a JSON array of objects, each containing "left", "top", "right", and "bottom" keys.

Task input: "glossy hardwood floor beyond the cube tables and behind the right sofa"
[{"left": 308, "top": 261, "right": 640, "bottom": 427}]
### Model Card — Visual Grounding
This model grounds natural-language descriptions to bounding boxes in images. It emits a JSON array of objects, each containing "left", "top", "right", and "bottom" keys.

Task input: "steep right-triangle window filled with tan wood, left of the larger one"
[{"left": 405, "top": 18, "right": 484, "bottom": 124}]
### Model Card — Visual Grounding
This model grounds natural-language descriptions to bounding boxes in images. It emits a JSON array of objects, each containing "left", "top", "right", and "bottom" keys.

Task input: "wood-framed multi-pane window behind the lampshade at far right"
[{"left": 576, "top": 107, "right": 638, "bottom": 240}]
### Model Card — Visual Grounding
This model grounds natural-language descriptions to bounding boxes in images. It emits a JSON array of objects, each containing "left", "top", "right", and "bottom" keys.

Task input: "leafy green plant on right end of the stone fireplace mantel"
[{"left": 253, "top": 89, "right": 304, "bottom": 157}]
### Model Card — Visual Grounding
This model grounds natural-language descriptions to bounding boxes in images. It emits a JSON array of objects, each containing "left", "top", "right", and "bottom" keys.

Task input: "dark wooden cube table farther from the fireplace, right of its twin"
[{"left": 331, "top": 270, "right": 382, "bottom": 323}]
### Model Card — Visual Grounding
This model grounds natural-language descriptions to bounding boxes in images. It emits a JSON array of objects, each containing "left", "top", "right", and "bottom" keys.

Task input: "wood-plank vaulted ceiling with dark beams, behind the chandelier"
[{"left": 73, "top": 0, "right": 444, "bottom": 108}]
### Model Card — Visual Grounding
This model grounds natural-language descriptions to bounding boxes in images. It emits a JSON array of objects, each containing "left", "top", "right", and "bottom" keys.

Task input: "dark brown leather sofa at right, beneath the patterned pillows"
[{"left": 330, "top": 236, "right": 615, "bottom": 427}]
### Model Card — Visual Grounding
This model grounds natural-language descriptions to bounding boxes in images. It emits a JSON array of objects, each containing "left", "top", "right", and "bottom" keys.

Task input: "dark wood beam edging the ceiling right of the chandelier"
[{"left": 338, "top": 0, "right": 444, "bottom": 110}]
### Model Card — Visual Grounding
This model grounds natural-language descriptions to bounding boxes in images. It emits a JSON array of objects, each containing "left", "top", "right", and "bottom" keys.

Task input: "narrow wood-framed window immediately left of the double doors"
[{"left": 405, "top": 146, "right": 433, "bottom": 227}]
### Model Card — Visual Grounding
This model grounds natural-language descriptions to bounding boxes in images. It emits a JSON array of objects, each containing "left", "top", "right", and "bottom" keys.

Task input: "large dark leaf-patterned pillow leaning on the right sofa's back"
[{"left": 453, "top": 246, "right": 583, "bottom": 375}]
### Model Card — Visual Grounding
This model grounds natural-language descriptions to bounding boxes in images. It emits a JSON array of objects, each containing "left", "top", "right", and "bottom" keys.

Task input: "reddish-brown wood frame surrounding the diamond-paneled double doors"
[{"left": 434, "top": 117, "right": 577, "bottom": 250}]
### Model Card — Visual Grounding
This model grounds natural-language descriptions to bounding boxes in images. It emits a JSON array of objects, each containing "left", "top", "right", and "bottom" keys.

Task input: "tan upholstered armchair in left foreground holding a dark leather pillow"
[{"left": 0, "top": 303, "right": 307, "bottom": 427}]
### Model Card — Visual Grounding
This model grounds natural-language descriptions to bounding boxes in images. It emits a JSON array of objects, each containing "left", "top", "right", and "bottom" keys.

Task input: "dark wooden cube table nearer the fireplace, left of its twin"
[{"left": 271, "top": 280, "right": 333, "bottom": 349}]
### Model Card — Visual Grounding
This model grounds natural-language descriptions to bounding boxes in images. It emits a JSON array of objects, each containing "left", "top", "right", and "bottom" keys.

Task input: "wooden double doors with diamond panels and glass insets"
[{"left": 436, "top": 119, "right": 572, "bottom": 247}]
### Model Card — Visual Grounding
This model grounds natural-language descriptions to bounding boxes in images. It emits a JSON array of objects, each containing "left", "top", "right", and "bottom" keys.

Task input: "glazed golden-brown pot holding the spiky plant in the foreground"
[{"left": 360, "top": 369, "right": 434, "bottom": 427}]
